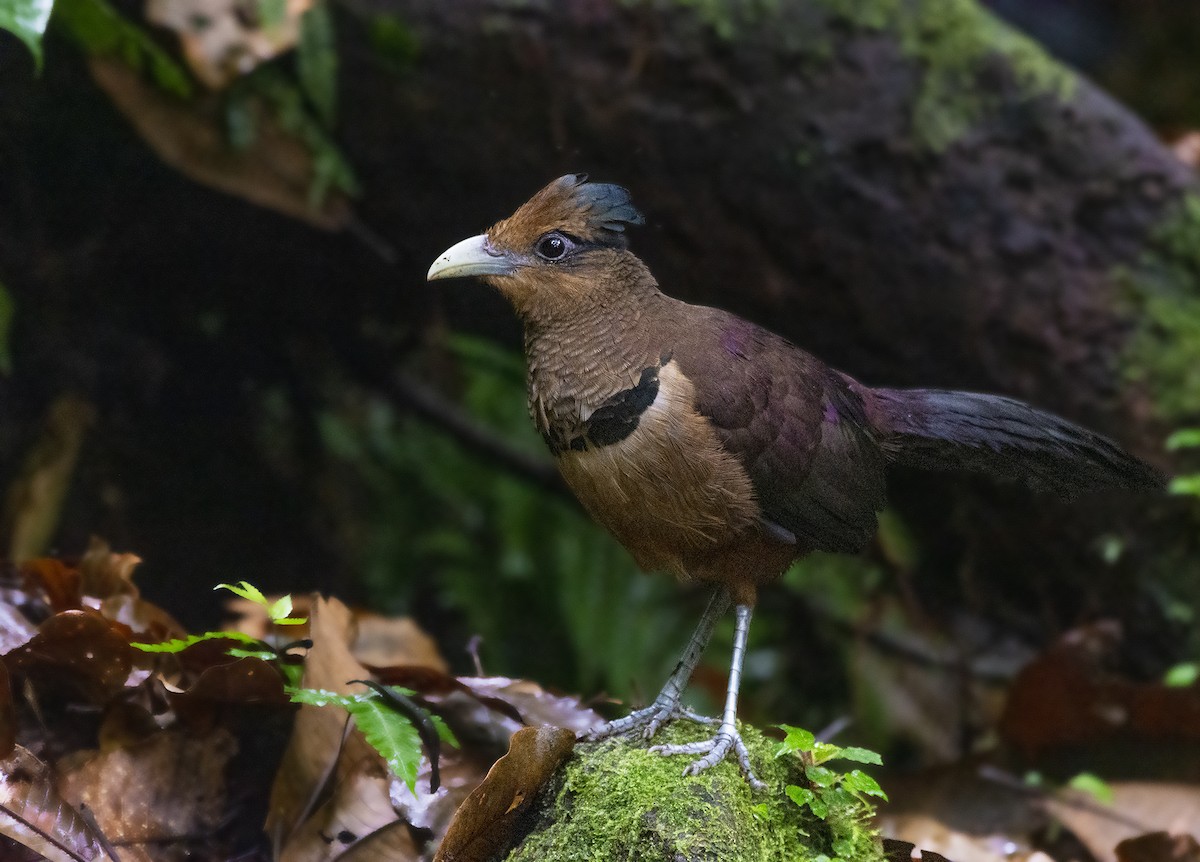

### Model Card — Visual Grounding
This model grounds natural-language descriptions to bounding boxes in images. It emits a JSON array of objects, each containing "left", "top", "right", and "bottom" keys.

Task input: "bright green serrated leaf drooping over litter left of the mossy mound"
[{"left": 288, "top": 686, "right": 458, "bottom": 790}]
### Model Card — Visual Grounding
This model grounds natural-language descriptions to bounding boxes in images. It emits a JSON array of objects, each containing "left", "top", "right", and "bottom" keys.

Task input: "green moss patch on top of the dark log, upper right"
[{"left": 816, "top": 0, "right": 1078, "bottom": 152}]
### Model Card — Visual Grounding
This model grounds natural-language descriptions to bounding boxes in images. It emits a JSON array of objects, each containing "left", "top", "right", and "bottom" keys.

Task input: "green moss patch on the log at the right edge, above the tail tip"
[{"left": 1114, "top": 193, "right": 1200, "bottom": 425}]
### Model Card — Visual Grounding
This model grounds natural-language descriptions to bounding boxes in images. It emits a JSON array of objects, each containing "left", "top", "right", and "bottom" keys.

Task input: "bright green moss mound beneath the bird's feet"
[{"left": 509, "top": 723, "right": 882, "bottom": 862}]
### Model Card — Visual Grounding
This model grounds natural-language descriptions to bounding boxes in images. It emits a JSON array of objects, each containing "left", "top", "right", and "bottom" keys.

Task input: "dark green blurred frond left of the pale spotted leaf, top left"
[{"left": 54, "top": 0, "right": 192, "bottom": 98}]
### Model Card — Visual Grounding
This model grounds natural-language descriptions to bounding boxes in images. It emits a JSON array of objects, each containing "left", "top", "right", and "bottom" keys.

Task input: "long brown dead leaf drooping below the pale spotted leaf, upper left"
[{"left": 88, "top": 55, "right": 349, "bottom": 231}]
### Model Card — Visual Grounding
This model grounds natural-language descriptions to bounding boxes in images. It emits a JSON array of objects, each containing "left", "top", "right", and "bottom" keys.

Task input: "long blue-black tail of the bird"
[{"left": 871, "top": 389, "right": 1163, "bottom": 495}]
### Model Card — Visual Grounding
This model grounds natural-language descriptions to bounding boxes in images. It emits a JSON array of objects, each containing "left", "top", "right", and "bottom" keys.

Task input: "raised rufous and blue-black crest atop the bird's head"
[{"left": 487, "top": 174, "right": 646, "bottom": 249}]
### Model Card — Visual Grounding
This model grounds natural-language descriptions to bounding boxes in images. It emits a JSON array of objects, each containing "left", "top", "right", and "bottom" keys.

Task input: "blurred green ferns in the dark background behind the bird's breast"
[{"left": 319, "top": 339, "right": 698, "bottom": 696}]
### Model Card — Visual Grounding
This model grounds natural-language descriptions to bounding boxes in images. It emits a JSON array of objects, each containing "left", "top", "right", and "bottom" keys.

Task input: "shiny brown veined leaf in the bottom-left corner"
[{"left": 0, "top": 746, "right": 103, "bottom": 862}]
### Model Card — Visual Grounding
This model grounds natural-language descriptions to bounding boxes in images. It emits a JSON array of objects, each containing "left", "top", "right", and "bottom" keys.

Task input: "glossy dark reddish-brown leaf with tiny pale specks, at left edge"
[{"left": 5, "top": 611, "right": 133, "bottom": 704}]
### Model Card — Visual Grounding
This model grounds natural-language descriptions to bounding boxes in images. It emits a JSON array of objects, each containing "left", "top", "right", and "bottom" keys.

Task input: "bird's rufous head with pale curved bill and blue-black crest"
[{"left": 428, "top": 174, "right": 644, "bottom": 312}]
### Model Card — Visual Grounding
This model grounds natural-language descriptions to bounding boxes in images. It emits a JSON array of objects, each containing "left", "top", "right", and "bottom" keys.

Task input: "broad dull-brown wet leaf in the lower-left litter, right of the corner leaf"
[{"left": 59, "top": 729, "right": 238, "bottom": 852}]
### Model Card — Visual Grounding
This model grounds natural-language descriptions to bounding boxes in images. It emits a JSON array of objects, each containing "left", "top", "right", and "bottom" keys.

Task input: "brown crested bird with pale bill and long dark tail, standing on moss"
[{"left": 428, "top": 174, "right": 1162, "bottom": 786}]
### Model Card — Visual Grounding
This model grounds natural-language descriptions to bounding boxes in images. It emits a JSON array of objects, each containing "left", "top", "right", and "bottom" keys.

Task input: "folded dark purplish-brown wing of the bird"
[{"left": 672, "top": 306, "right": 886, "bottom": 551}]
